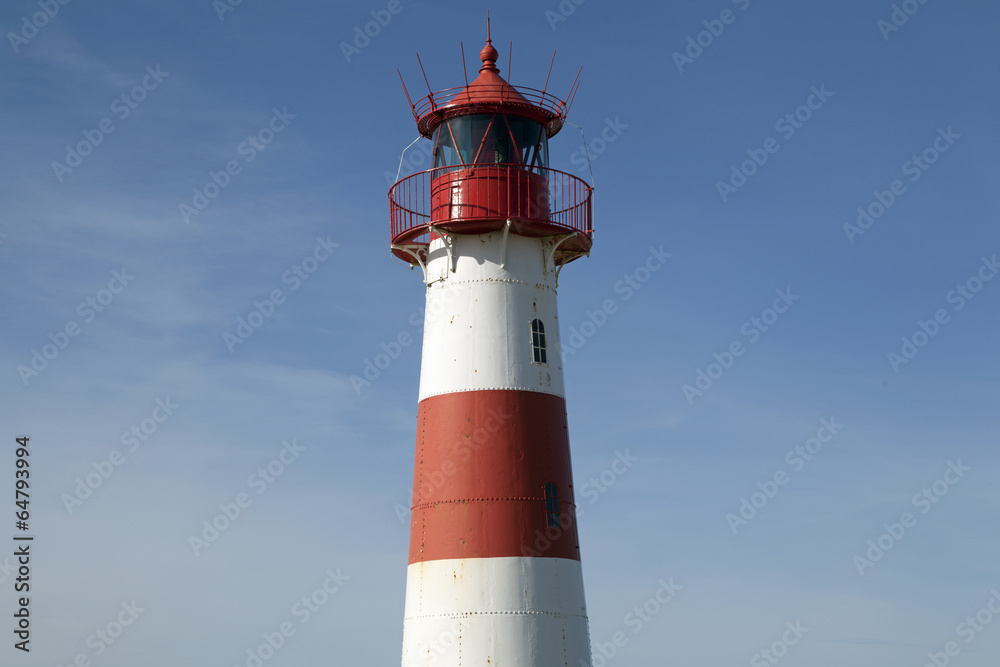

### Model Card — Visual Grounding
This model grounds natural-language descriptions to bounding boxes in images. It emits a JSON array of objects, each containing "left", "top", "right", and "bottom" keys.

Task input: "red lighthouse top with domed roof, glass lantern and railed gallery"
[{"left": 389, "top": 33, "right": 593, "bottom": 266}]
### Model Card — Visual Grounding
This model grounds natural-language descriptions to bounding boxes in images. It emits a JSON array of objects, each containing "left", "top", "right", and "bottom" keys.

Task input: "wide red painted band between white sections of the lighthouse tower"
[{"left": 410, "top": 390, "right": 580, "bottom": 563}]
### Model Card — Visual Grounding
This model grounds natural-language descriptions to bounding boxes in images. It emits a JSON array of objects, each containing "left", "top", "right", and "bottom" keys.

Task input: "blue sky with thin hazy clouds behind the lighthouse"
[{"left": 0, "top": 0, "right": 1000, "bottom": 667}]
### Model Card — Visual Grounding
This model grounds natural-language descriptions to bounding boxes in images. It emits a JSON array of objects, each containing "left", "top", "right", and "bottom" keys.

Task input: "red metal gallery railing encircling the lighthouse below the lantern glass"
[{"left": 389, "top": 164, "right": 593, "bottom": 242}]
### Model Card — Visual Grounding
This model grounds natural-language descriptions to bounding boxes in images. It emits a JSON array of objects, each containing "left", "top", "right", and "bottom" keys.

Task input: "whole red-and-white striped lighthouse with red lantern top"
[{"left": 389, "top": 30, "right": 593, "bottom": 667}]
